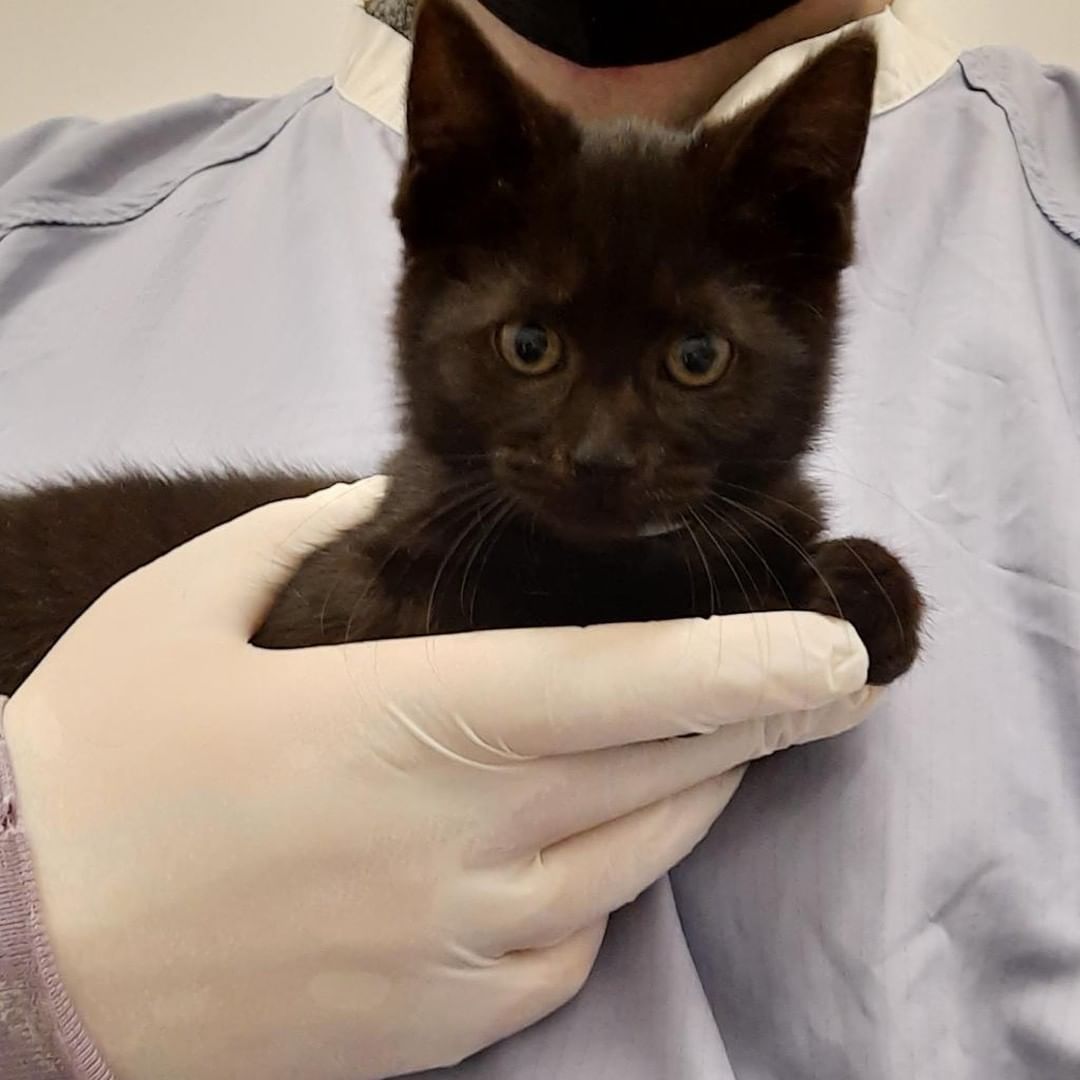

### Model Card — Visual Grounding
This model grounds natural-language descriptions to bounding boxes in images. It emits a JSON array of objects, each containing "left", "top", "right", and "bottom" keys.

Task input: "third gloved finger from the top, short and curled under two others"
[{"left": 475, "top": 766, "right": 745, "bottom": 956}]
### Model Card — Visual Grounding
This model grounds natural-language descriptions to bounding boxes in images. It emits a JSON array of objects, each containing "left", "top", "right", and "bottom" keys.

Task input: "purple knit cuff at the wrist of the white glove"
[{"left": 0, "top": 698, "right": 112, "bottom": 1080}]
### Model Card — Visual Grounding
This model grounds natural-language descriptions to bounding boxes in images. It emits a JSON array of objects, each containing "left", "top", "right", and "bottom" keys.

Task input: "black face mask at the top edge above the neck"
[{"left": 481, "top": 0, "right": 797, "bottom": 67}]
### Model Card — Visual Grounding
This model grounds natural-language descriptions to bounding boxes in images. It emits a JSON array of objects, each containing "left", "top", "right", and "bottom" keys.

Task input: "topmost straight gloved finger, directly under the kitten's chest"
[{"left": 336, "top": 611, "right": 867, "bottom": 764}]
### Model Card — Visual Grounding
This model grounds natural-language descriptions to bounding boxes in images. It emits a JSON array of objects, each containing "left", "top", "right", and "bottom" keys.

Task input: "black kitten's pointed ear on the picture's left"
[{"left": 394, "top": 0, "right": 577, "bottom": 249}]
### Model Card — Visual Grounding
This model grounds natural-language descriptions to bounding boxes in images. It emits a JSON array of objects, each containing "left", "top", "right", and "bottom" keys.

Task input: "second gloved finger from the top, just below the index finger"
[{"left": 501, "top": 687, "right": 878, "bottom": 858}]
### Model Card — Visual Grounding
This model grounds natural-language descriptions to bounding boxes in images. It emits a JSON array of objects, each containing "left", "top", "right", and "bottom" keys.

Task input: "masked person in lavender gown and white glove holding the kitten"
[{"left": 0, "top": 0, "right": 1080, "bottom": 1080}]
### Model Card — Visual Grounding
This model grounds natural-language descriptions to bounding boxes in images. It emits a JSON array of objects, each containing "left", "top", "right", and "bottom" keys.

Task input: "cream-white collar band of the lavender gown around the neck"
[{"left": 335, "top": 0, "right": 959, "bottom": 133}]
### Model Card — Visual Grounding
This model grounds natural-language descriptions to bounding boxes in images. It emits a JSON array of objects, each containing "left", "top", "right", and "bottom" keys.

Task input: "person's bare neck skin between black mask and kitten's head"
[{"left": 458, "top": 0, "right": 890, "bottom": 125}]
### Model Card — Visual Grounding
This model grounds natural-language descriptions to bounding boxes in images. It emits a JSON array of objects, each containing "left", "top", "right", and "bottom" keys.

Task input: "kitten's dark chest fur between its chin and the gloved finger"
[{"left": 257, "top": 466, "right": 816, "bottom": 647}]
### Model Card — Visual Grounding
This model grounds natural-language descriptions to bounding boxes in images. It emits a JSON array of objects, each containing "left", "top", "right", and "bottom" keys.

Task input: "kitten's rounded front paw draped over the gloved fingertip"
[{"left": 805, "top": 537, "right": 923, "bottom": 686}]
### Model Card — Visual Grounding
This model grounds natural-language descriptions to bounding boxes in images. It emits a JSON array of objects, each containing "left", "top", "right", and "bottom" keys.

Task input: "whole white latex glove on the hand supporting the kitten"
[{"left": 6, "top": 482, "right": 870, "bottom": 1080}]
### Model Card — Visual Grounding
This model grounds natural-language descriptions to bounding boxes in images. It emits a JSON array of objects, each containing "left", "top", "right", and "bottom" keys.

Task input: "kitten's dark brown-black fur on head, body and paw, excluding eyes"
[{"left": 0, "top": 0, "right": 921, "bottom": 692}]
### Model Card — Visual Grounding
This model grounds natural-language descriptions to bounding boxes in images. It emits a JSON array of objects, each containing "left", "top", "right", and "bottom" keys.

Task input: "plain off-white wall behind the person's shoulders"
[{"left": 0, "top": 0, "right": 1080, "bottom": 133}]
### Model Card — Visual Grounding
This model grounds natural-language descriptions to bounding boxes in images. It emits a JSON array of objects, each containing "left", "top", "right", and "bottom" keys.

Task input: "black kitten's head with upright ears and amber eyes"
[{"left": 395, "top": 0, "right": 876, "bottom": 541}]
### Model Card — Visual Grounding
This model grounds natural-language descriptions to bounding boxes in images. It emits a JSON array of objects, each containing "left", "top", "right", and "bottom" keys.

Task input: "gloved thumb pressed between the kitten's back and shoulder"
[{"left": 159, "top": 476, "right": 387, "bottom": 640}]
